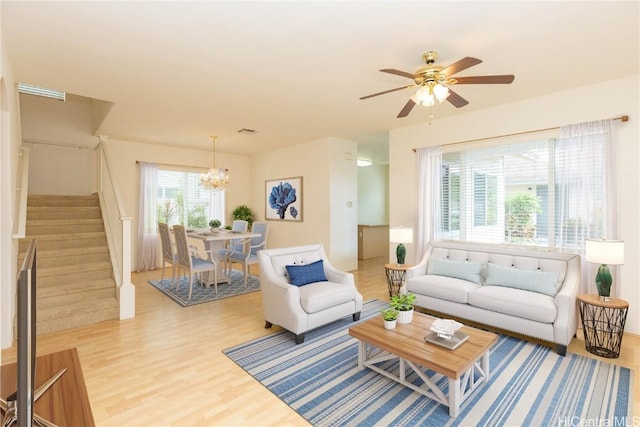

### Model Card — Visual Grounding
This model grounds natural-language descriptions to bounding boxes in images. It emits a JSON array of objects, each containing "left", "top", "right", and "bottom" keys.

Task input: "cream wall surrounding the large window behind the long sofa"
[{"left": 389, "top": 75, "right": 640, "bottom": 334}]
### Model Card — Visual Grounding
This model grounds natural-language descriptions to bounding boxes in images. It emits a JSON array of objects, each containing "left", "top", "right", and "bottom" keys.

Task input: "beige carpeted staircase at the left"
[{"left": 18, "top": 195, "right": 119, "bottom": 335}]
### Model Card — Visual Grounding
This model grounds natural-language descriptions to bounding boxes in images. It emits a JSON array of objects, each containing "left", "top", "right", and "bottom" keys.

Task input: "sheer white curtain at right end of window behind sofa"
[{"left": 555, "top": 119, "right": 617, "bottom": 293}]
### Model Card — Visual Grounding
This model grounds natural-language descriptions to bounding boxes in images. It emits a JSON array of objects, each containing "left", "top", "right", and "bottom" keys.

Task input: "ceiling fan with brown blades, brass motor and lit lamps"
[{"left": 360, "top": 51, "right": 514, "bottom": 118}]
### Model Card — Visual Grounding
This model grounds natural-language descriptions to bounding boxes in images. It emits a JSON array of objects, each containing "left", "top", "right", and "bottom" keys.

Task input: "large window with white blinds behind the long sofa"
[{"left": 439, "top": 135, "right": 606, "bottom": 248}]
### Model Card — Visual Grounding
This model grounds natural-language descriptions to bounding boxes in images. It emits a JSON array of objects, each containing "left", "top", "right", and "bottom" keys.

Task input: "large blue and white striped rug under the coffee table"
[{"left": 223, "top": 300, "right": 633, "bottom": 426}]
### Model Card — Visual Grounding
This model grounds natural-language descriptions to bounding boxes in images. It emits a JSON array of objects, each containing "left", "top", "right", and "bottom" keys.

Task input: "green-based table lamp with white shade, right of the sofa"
[{"left": 585, "top": 239, "right": 624, "bottom": 301}]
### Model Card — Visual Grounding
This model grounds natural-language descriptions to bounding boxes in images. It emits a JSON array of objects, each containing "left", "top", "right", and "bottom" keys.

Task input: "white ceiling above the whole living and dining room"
[{"left": 1, "top": 0, "right": 640, "bottom": 161}]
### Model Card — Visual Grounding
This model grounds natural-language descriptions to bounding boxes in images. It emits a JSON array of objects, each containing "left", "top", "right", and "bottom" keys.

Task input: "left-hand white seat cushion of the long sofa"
[{"left": 407, "top": 274, "right": 480, "bottom": 304}]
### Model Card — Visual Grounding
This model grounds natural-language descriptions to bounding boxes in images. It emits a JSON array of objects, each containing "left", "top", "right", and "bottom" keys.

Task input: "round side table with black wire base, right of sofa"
[{"left": 578, "top": 294, "right": 629, "bottom": 359}]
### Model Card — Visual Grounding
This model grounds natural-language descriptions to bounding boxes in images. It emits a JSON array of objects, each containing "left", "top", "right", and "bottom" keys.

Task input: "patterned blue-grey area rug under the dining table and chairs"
[{"left": 149, "top": 270, "right": 260, "bottom": 307}]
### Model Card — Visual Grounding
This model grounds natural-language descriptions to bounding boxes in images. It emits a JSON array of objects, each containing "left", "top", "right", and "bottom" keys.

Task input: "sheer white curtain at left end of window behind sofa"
[{"left": 416, "top": 145, "right": 442, "bottom": 262}]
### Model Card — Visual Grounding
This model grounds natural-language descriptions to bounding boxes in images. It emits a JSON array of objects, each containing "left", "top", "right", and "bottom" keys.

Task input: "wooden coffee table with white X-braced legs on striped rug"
[{"left": 349, "top": 312, "right": 498, "bottom": 418}]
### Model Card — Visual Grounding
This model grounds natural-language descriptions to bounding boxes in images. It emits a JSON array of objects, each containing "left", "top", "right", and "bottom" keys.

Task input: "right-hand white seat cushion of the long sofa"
[{"left": 469, "top": 285, "right": 557, "bottom": 322}]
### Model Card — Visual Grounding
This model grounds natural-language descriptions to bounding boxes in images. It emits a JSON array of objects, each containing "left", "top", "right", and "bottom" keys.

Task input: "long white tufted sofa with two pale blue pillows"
[{"left": 405, "top": 242, "right": 580, "bottom": 355}]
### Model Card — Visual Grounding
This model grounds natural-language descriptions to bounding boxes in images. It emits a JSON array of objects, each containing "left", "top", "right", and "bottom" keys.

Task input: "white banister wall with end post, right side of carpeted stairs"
[{"left": 96, "top": 136, "right": 135, "bottom": 319}]
